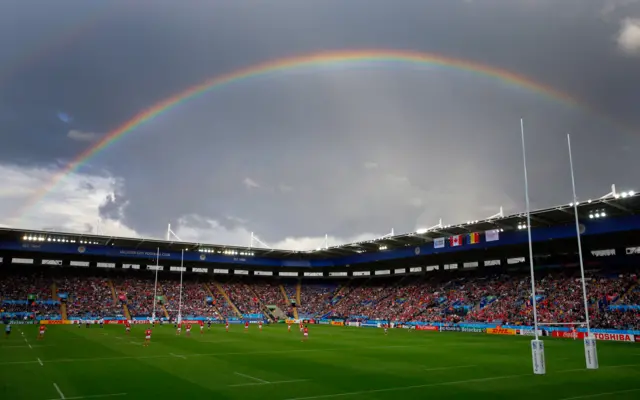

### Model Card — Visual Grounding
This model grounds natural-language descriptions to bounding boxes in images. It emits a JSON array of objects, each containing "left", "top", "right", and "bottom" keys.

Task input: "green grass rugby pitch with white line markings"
[{"left": 0, "top": 325, "right": 640, "bottom": 400}]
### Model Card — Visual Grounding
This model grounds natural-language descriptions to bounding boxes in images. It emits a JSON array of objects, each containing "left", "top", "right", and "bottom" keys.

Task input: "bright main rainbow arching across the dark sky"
[{"left": 17, "top": 50, "right": 584, "bottom": 219}]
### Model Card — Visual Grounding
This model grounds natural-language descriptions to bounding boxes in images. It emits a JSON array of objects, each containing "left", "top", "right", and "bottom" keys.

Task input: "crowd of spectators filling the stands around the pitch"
[{"left": 0, "top": 270, "right": 640, "bottom": 328}]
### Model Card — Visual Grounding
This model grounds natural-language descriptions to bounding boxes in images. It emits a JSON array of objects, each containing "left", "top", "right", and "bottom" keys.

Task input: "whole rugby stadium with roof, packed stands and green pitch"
[{"left": 0, "top": 192, "right": 640, "bottom": 400}]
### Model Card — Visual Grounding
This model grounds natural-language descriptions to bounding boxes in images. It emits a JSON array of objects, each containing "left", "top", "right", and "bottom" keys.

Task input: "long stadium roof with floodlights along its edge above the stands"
[{"left": 0, "top": 192, "right": 640, "bottom": 259}]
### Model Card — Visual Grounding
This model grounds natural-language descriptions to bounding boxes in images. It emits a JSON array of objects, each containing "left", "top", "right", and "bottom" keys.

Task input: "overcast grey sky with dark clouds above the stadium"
[{"left": 0, "top": 0, "right": 640, "bottom": 249}]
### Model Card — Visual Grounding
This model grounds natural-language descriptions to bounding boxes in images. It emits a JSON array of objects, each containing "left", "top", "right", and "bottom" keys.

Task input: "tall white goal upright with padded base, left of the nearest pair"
[{"left": 520, "top": 118, "right": 547, "bottom": 375}]
